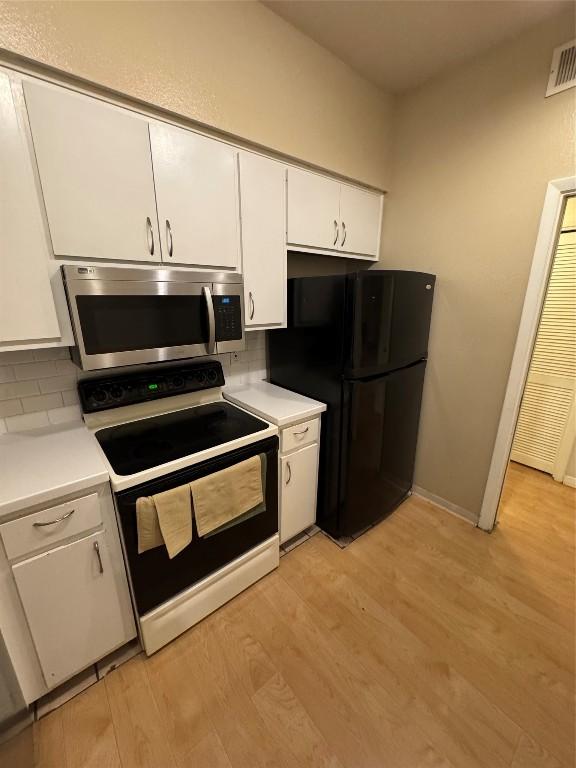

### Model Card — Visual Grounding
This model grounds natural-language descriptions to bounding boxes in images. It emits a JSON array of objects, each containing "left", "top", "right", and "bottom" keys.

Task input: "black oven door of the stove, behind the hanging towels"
[{"left": 115, "top": 437, "right": 278, "bottom": 616}]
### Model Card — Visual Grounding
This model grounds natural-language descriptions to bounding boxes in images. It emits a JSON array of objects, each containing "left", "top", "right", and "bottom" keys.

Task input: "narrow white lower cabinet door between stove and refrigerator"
[{"left": 280, "top": 443, "right": 318, "bottom": 543}]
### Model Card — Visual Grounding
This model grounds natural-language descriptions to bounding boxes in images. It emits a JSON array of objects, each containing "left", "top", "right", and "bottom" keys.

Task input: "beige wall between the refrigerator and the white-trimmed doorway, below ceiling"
[{"left": 382, "top": 10, "right": 575, "bottom": 515}]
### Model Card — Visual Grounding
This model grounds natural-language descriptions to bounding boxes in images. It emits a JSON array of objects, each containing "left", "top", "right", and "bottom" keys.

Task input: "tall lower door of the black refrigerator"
[{"left": 338, "top": 361, "right": 426, "bottom": 536}]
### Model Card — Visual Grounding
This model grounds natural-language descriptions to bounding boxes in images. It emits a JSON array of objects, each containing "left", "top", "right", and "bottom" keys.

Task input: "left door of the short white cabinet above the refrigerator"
[{"left": 288, "top": 168, "right": 340, "bottom": 250}]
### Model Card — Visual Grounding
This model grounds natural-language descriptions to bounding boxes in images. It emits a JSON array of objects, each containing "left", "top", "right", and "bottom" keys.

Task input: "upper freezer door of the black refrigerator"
[{"left": 346, "top": 270, "right": 436, "bottom": 378}]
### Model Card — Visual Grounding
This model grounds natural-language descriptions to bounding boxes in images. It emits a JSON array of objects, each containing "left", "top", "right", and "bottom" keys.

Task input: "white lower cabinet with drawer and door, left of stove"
[{"left": 0, "top": 484, "right": 136, "bottom": 704}]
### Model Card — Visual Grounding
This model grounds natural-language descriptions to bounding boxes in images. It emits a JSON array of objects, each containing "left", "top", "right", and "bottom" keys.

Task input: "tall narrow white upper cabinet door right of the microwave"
[{"left": 240, "top": 153, "right": 286, "bottom": 328}]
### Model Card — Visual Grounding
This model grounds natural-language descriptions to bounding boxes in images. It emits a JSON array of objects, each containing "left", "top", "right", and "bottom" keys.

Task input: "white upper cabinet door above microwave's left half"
[{"left": 24, "top": 82, "right": 160, "bottom": 261}]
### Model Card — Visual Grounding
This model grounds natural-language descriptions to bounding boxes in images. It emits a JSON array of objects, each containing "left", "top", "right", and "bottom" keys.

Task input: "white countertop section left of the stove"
[{"left": 0, "top": 423, "right": 108, "bottom": 518}]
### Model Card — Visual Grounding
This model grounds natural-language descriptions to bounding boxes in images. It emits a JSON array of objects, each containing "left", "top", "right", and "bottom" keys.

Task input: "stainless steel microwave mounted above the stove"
[{"left": 62, "top": 265, "right": 244, "bottom": 371}]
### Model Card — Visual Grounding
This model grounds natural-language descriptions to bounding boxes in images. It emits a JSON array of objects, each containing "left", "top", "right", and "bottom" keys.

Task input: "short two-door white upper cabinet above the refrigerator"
[{"left": 287, "top": 168, "right": 383, "bottom": 259}]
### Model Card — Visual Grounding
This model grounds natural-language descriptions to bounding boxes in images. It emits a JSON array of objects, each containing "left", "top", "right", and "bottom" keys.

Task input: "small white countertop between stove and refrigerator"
[{"left": 224, "top": 381, "right": 326, "bottom": 427}]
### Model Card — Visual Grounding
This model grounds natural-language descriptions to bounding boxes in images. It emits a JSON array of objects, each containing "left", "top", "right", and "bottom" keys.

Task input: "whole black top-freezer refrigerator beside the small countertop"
[{"left": 268, "top": 270, "right": 436, "bottom": 538}]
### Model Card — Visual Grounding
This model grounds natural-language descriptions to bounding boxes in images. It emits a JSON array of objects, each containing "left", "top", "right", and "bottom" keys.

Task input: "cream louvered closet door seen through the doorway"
[{"left": 511, "top": 232, "right": 576, "bottom": 481}]
